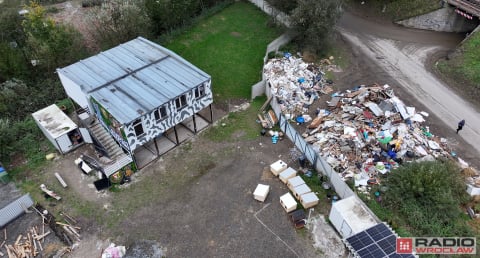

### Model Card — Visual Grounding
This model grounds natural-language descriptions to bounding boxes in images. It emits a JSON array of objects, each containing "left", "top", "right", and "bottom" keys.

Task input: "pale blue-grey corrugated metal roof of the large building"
[{"left": 57, "top": 37, "right": 210, "bottom": 124}]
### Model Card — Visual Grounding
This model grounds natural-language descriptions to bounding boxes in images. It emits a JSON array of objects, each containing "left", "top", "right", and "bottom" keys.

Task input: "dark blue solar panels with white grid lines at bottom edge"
[{"left": 346, "top": 223, "right": 416, "bottom": 258}]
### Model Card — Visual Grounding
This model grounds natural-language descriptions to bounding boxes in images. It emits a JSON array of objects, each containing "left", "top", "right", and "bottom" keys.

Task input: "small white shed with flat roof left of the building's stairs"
[{"left": 32, "top": 104, "right": 92, "bottom": 154}]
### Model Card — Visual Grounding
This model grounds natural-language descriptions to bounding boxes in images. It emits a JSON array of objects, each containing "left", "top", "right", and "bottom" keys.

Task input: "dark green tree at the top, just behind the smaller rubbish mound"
[{"left": 290, "top": 0, "right": 342, "bottom": 54}]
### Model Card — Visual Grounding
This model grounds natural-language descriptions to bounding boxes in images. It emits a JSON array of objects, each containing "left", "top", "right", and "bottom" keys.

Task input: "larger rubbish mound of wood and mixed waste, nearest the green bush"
[{"left": 303, "top": 85, "right": 458, "bottom": 186}]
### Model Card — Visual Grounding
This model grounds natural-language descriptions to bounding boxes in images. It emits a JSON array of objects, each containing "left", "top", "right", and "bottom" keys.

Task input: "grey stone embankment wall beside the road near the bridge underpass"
[{"left": 397, "top": 5, "right": 479, "bottom": 32}]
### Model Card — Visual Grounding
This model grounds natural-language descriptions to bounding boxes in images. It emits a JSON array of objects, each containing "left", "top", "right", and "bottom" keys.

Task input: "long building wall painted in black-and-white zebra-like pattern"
[{"left": 124, "top": 81, "right": 213, "bottom": 152}]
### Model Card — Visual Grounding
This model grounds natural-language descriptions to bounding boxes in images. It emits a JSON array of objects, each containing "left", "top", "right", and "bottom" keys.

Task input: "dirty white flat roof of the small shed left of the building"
[{"left": 32, "top": 104, "right": 77, "bottom": 139}]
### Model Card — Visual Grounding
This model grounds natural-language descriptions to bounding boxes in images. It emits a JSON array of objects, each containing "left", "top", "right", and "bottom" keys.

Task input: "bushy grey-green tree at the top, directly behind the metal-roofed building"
[{"left": 88, "top": 0, "right": 151, "bottom": 48}]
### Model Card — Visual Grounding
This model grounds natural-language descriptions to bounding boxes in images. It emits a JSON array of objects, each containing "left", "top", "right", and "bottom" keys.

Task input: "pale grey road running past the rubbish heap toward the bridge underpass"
[{"left": 338, "top": 13, "right": 480, "bottom": 161}]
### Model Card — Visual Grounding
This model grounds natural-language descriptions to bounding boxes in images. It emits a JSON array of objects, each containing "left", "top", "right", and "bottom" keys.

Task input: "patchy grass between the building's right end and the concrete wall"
[{"left": 204, "top": 96, "right": 266, "bottom": 142}]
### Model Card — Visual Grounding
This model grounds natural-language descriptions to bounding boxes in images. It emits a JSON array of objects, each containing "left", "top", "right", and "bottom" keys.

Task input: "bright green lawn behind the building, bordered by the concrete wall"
[{"left": 165, "top": 2, "right": 281, "bottom": 101}]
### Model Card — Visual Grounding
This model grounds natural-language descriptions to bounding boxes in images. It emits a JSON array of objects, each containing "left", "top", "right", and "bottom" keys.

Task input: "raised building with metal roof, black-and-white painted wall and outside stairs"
[{"left": 57, "top": 37, "right": 213, "bottom": 173}]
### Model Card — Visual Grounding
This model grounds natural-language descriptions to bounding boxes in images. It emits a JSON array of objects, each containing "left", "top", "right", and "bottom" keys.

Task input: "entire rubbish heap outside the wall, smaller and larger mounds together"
[{"left": 264, "top": 57, "right": 468, "bottom": 189}]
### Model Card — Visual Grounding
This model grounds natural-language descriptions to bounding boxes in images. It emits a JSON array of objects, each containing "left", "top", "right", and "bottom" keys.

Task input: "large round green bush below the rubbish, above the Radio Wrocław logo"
[{"left": 382, "top": 161, "right": 469, "bottom": 236}]
